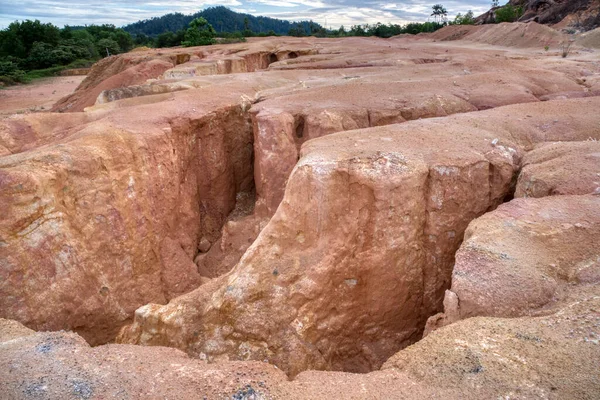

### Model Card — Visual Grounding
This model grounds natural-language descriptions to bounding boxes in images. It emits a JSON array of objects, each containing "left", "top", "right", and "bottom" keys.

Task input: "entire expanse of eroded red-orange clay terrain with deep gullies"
[{"left": 0, "top": 23, "right": 600, "bottom": 399}]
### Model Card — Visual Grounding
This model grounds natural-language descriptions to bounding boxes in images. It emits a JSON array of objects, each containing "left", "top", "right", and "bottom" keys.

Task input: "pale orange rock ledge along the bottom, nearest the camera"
[{"left": 0, "top": 292, "right": 600, "bottom": 399}]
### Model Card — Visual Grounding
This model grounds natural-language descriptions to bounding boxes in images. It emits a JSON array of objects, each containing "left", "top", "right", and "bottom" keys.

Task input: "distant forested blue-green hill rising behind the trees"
[{"left": 123, "top": 6, "right": 321, "bottom": 36}]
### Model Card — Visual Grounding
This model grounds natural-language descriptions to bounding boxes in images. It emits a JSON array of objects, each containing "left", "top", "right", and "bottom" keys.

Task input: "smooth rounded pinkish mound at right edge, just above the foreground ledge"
[{"left": 429, "top": 195, "right": 600, "bottom": 328}]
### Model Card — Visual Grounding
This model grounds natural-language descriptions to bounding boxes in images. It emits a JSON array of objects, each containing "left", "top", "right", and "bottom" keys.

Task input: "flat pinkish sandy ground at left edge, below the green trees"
[{"left": 0, "top": 76, "right": 85, "bottom": 115}]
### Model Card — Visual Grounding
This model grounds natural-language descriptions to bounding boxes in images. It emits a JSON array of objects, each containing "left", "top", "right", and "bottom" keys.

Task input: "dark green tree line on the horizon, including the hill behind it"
[{"left": 0, "top": 4, "right": 522, "bottom": 84}]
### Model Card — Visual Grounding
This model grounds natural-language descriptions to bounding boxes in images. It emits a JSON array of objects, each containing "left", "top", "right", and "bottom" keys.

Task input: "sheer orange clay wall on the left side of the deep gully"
[{"left": 0, "top": 90, "right": 253, "bottom": 343}]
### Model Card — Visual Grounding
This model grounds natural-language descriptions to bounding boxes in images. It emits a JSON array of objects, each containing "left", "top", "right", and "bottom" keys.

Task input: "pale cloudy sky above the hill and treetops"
[{"left": 0, "top": 0, "right": 496, "bottom": 29}]
